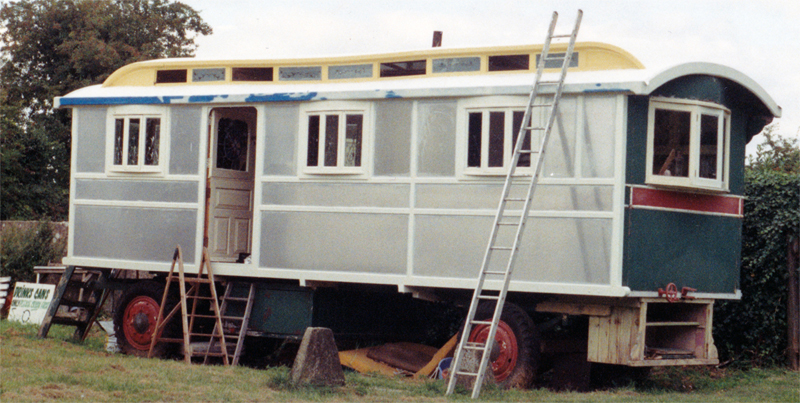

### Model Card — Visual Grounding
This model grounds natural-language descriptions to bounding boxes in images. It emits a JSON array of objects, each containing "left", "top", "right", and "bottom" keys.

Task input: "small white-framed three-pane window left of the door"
[{"left": 108, "top": 107, "right": 165, "bottom": 172}]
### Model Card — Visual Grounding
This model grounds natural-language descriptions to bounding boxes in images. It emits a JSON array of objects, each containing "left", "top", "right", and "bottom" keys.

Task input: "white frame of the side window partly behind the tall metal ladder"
[{"left": 456, "top": 96, "right": 544, "bottom": 178}]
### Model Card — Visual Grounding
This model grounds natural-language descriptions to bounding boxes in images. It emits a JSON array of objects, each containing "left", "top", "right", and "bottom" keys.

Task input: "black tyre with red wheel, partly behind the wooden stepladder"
[{"left": 114, "top": 281, "right": 176, "bottom": 357}]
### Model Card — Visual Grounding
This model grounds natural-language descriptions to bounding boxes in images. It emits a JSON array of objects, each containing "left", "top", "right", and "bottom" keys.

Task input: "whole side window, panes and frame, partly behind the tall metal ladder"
[{"left": 459, "top": 97, "right": 541, "bottom": 175}]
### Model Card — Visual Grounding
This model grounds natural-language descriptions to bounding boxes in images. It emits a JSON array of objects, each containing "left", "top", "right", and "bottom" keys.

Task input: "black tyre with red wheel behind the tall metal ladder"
[{"left": 469, "top": 303, "right": 539, "bottom": 389}]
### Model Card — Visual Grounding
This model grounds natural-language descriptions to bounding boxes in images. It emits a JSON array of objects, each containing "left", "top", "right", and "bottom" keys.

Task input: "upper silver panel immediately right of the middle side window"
[{"left": 374, "top": 100, "right": 413, "bottom": 176}]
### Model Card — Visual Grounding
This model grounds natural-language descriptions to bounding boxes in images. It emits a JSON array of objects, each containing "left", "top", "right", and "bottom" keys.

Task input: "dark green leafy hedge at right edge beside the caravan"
[{"left": 714, "top": 169, "right": 800, "bottom": 366}]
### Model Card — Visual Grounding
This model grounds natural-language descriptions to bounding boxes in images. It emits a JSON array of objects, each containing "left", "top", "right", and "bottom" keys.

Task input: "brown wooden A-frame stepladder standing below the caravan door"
[{"left": 147, "top": 245, "right": 230, "bottom": 365}]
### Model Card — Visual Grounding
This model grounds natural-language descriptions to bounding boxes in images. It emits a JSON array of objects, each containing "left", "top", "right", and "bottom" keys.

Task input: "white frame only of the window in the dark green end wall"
[{"left": 645, "top": 97, "right": 731, "bottom": 192}]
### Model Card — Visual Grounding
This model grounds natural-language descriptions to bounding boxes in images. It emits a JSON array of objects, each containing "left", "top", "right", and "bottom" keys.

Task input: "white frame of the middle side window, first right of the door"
[{"left": 297, "top": 101, "right": 375, "bottom": 176}]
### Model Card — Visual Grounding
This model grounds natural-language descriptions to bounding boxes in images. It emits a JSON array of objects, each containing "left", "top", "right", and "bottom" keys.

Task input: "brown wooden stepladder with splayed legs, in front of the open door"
[{"left": 148, "top": 246, "right": 231, "bottom": 365}]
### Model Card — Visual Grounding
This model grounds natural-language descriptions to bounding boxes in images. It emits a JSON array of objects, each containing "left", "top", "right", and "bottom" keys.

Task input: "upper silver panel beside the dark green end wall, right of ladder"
[{"left": 580, "top": 94, "right": 622, "bottom": 178}]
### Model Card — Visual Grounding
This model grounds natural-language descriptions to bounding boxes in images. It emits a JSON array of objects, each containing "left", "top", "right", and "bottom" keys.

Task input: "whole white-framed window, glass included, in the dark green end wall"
[{"left": 647, "top": 98, "right": 730, "bottom": 190}]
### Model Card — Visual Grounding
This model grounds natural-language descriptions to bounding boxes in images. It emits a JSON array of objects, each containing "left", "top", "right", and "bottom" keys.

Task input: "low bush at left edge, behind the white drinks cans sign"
[{"left": 0, "top": 221, "right": 66, "bottom": 287}]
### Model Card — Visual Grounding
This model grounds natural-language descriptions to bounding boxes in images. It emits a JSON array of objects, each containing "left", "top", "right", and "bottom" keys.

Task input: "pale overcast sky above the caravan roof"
[{"left": 181, "top": 0, "right": 800, "bottom": 153}]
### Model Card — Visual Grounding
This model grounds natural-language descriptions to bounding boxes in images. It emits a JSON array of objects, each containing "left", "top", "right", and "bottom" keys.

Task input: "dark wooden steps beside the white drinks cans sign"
[{"left": 39, "top": 266, "right": 113, "bottom": 341}]
